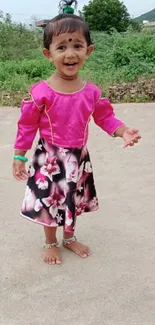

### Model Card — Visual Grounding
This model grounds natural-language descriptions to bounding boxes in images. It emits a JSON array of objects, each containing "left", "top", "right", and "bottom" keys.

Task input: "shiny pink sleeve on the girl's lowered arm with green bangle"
[{"left": 14, "top": 100, "right": 40, "bottom": 150}]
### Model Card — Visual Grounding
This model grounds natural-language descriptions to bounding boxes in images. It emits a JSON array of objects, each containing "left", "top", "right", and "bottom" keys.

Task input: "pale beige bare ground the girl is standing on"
[{"left": 0, "top": 104, "right": 155, "bottom": 325}]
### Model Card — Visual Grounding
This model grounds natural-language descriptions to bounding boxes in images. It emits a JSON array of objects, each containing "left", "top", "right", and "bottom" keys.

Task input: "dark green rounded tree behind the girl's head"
[{"left": 83, "top": 0, "right": 130, "bottom": 32}]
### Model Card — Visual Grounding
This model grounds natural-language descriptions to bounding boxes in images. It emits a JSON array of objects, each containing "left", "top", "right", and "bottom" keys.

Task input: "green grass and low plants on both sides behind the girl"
[{"left": 0, "top": 25, "right": 155, "bottom": 105}]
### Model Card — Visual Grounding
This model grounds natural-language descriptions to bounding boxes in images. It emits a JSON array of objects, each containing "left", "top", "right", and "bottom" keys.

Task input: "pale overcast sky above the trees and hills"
[{"left": 0, "top": 0, "right": 155, "bottom": 23}]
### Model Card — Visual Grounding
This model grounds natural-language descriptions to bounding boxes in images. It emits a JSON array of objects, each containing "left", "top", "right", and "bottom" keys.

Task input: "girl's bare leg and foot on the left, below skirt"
[{"left": 44, "top": 227, "right": 61, "bottom": 264}]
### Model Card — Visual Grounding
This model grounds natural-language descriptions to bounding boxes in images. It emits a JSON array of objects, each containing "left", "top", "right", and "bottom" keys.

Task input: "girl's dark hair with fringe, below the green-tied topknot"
[{"left": 44, "top": 14, "right": 93, "bottom": 50}]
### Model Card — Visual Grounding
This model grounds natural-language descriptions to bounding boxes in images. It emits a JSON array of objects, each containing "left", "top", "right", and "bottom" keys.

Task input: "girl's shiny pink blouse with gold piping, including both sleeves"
[{"left": 14, "top": 81, "right": 124, "bottom": 150}]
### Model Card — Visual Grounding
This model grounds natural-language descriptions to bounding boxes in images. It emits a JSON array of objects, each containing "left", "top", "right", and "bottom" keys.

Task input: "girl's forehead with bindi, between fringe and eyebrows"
[{"left": 52, "top": 31, "right": 87, "bottom": 44}]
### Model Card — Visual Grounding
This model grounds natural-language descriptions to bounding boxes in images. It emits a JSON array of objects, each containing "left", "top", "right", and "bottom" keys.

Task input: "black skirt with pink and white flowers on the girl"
[{"left": 21, "top": 139, "right": 98, "bottom": 232}]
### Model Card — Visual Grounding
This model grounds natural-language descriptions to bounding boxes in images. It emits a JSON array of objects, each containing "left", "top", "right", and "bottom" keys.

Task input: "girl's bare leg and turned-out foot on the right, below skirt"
[{"left": 63, "top": 231, "right": 90, "bottom": 258}]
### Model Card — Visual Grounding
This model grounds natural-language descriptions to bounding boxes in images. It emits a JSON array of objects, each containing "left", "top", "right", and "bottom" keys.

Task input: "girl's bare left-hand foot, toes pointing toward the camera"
[{"left": 44, "top": 246, "right": 61, "bottom": 265}]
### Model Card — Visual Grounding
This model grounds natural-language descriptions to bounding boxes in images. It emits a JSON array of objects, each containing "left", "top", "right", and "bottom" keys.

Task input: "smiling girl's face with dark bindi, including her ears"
[{"left": 43, "top": 32, "right": 94, "bottom": 78}]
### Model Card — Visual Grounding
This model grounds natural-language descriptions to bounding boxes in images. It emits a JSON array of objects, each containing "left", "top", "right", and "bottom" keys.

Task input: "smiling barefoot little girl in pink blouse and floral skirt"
[{"left": 13, "top": 14, "right": 140, "bottom": 264}]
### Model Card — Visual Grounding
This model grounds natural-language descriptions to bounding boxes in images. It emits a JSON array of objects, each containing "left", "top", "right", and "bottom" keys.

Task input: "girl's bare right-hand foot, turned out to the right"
[{"left": 63, "top": 241, "right": 90, "bottom": 258}]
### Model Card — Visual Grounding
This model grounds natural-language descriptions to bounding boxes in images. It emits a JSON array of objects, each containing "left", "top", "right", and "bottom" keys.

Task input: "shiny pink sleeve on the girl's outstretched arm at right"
[{"left": 93, "top": 98, "right": 124, "bottom": 136}]
